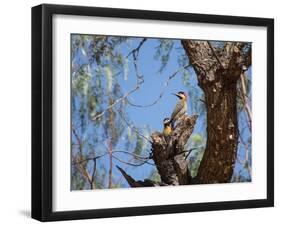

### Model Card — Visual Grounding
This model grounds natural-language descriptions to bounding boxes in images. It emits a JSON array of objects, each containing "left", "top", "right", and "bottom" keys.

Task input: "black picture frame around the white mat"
[{"left": 32, "top": 4, "right": 274, "bottom": 221}]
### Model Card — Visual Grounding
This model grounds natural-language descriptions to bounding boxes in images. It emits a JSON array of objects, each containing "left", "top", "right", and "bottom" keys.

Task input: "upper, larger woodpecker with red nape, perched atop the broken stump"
[{"left": 170, "top": 91, "right": 187, "bottom": 128}]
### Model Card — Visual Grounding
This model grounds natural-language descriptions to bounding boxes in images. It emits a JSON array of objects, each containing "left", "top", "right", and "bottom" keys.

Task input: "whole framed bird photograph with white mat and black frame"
[{"left": 32, "top": 4, "right": 274, "bottom": 221}]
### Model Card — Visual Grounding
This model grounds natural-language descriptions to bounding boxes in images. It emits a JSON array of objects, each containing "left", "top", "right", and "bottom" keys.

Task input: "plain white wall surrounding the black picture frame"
[{"left": 0, "top": 0, "right": 276, "bottom": 226}]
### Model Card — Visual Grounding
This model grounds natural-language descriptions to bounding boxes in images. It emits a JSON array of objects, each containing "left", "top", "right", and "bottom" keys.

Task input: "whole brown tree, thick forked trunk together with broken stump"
[{"left": 119, "top": 40, "right": 251, "bottom": 187}]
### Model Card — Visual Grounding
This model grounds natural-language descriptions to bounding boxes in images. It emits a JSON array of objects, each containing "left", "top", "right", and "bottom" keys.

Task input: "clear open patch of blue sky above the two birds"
[{"left": 120, "top": 40, "right": 201, "bottom": 130}]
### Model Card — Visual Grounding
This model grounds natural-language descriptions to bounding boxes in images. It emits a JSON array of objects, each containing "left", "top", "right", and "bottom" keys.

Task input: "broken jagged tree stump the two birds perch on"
[{"left": 119, "top": 115, "right": 198, "bottom": 187}]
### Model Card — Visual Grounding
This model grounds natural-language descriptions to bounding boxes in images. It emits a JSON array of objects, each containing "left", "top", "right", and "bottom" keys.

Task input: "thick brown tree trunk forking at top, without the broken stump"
[{"left": 182, "top": 40, "right": 244, "bottom": 184}]
